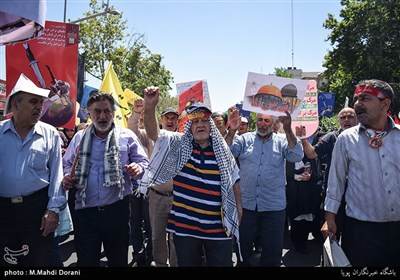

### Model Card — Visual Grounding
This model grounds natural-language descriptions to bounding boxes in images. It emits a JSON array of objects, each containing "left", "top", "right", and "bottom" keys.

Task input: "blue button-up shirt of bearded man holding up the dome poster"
[{"left": 230, "top": 132, "right": 304, "bottom": 212}]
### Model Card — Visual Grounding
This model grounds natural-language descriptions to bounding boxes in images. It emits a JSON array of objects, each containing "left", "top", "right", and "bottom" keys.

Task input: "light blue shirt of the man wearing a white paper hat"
[{"left": 0, "top": 119, "right": 67, "bottom": 209}]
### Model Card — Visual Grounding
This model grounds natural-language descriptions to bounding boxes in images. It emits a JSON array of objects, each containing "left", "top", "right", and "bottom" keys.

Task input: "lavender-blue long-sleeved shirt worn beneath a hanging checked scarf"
[{"left": 63, "top": 128, "right": 149, "bottom": 209}]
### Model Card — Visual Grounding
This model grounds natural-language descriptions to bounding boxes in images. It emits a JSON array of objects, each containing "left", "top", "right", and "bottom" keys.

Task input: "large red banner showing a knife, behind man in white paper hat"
[{"left": 6, "top": 21, "right": 79, "bottom": 128}]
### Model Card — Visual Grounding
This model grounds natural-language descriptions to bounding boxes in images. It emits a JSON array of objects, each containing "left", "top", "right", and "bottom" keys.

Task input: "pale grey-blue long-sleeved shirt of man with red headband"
[{"left": 325, "top": 119, "right": 400, "bottom": 222}]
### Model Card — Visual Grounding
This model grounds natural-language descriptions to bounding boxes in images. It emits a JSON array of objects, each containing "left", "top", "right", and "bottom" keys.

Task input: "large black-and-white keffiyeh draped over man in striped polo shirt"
[{"left": 139, "top": 118, "right": 239, "bottom": 253}]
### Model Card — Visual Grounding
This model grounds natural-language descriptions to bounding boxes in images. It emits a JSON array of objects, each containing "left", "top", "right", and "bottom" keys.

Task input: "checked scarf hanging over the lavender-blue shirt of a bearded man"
[{"left": 75, "top": 124, "right": 125, "bottom": 206}]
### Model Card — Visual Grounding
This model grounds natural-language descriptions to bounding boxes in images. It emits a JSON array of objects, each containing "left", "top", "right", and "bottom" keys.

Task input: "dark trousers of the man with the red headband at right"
[{"left": 342, "top": 217, "right": 400, "bottom": 267}]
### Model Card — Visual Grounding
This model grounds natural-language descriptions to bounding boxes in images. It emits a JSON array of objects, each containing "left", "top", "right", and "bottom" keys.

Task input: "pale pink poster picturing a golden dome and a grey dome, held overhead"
[{"left": 243, "top": 72, "right": 308, "bottom": 119}]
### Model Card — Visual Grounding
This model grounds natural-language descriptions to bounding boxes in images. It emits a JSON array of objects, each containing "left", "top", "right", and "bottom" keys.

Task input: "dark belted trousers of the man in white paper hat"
[{"left": 0, "top": 188, "right": 54, "bottom": 267}]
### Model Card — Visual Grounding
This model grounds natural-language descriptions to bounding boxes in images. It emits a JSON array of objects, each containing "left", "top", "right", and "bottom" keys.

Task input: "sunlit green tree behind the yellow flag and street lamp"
[{"left": 75, "top": 0, "right": 177, "bottom": 109}]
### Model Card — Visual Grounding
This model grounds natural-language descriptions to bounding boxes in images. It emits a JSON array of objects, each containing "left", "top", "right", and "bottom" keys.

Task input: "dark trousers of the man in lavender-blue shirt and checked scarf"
[{"left": 74, "top": 197, "right": 129, "bottom": 267}]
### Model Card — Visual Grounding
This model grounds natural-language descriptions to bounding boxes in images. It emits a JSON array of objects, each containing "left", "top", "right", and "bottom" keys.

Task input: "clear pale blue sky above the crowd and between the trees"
[{"left": 0, "top": 0, "right": 342, "bottom": 111}]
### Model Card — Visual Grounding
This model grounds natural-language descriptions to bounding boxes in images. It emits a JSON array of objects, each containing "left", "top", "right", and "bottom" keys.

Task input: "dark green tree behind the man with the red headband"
[{"left": 322, "top": 0, "right": 400, "bottom": 112}]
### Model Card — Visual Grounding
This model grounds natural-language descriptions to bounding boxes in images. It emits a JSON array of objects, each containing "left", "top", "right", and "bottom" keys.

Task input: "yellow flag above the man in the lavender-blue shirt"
[{"left": 99, "top": 61, "right": 131, "bottom": 128}]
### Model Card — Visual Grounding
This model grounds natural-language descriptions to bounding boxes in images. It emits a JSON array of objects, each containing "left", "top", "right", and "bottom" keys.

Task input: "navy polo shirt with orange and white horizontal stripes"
[{"left": 167, "top": 143, "right": 231, "bottom": 240}]
